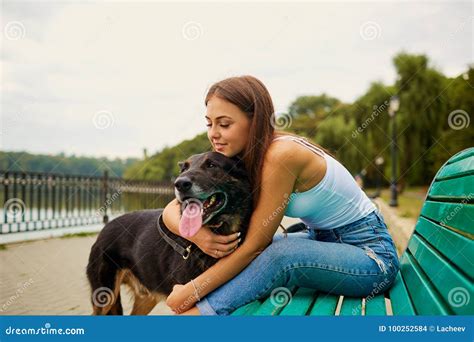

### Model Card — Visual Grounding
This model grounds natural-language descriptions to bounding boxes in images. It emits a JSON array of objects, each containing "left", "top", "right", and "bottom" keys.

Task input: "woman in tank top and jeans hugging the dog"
[{"left": 164, "top": 76, "right": 399, "bottom": 315}]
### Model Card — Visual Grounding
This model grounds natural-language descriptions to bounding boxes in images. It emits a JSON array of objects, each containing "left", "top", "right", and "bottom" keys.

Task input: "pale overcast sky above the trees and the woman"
[{"left": 0, "top": 1, "right": 474, "bottom": 157}]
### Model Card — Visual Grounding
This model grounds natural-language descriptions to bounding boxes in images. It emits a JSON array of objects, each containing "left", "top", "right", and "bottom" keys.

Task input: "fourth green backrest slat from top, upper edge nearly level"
[{"left": 421, "top": 201, "right": 474, "bottom": 236}]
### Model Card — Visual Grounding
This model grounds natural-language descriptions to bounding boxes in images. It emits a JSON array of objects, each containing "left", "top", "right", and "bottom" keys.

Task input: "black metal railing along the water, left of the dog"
[{"left": 0, "top": 171, "right": 174, "bottom": 234}]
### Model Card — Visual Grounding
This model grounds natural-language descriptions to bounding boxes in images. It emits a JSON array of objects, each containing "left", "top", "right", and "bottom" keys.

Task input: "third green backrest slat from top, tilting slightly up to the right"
[{"left": 428, "top": 175, "right": 474, "bottom": 199}]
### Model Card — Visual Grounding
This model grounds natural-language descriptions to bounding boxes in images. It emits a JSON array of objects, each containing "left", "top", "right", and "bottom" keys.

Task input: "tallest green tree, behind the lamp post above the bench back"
[{"left": 393, "top": 52, "right": 447, "bottom": 184}]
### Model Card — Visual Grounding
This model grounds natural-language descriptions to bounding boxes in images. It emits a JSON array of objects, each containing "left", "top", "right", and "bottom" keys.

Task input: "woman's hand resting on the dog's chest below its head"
[{"left": 192, "top": 226, "right": 241, "bottom": 259}]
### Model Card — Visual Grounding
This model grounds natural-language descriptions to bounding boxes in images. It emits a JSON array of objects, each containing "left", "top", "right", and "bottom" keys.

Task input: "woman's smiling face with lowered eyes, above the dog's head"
[{"left": 206, "top": 96, "right": 251, "bottom": 157}]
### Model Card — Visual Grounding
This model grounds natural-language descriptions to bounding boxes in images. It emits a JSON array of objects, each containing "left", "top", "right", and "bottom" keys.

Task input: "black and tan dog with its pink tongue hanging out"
[{"left": 87, "top": 152, "right": 252, "bottom": 315}]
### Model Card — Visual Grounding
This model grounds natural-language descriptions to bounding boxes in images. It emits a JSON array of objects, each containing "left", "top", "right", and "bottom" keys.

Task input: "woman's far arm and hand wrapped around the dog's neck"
[{"left": 163, "top": 198, "right": 243, "bottom": 258}]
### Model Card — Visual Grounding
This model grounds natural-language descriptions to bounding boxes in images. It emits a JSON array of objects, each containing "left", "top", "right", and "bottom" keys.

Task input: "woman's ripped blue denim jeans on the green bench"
[{"left": 196, "top": 210, "right": 399, "bottom": 315}]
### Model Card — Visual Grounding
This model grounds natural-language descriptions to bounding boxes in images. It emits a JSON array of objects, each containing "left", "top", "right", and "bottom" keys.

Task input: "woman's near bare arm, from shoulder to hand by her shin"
[{"left": 166, "top": 146, "right": 302, "bottom": 313}]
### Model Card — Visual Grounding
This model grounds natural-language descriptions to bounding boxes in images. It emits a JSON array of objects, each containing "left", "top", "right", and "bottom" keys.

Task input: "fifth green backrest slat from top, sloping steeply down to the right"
[{"left": 416, "top": 217, "right": 474, "bottom": 281}]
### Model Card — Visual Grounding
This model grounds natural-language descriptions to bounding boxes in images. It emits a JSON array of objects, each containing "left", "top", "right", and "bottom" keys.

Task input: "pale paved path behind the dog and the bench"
[{"left": 0, "top": 204, "right": 414, "bottom": 315}]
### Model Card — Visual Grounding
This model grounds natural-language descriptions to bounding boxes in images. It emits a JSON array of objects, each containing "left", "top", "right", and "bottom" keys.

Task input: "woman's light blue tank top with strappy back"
[{"left": 273, "top": 135, "right": 376, "bottom": 229}]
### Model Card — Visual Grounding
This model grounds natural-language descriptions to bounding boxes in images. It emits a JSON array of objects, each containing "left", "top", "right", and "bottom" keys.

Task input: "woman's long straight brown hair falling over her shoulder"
[{"left": 204, "top": 75, "right": 328, "bottom": 208}]
